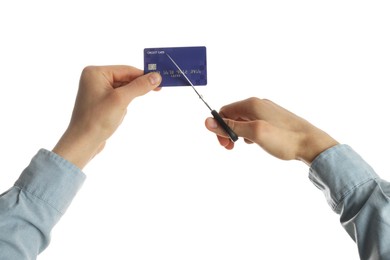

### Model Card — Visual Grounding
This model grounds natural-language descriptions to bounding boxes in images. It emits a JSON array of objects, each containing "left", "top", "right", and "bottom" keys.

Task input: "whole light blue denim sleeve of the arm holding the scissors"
[{"left": 309, "top": 145, "right": 390, "bottom": 259}]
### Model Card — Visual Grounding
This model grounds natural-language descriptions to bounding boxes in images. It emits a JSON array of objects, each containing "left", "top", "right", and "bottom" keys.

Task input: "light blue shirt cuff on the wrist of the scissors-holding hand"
[{"left": 309, "top": 144, "right": 379, "bottom": 213}]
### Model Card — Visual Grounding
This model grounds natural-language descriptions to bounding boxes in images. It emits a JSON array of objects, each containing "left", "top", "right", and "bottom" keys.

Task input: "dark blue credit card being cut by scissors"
[{"left": 144, "top": 46, "right": 207, "bottom": 87}]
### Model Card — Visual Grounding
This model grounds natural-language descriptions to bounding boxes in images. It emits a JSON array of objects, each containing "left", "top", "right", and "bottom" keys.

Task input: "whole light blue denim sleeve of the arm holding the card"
[{"left": 0, "top": 149, "right": 85, "bottom": 260}]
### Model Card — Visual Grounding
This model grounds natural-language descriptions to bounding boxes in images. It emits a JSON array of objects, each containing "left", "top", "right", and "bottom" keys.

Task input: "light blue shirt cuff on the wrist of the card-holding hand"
[{"left": 15, "top": 149, "right": 86, "bottom": 214}]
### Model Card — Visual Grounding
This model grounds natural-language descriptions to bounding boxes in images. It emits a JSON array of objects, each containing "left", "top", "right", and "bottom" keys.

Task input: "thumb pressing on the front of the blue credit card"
[{"left": 117, "top": 72, "right": 161, "bottom": 102}]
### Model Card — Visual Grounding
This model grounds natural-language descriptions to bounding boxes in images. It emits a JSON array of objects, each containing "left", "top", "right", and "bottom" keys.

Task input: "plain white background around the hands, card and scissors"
[{"left": 0, "top": 0, "right": 390, "bottom": 260}]
